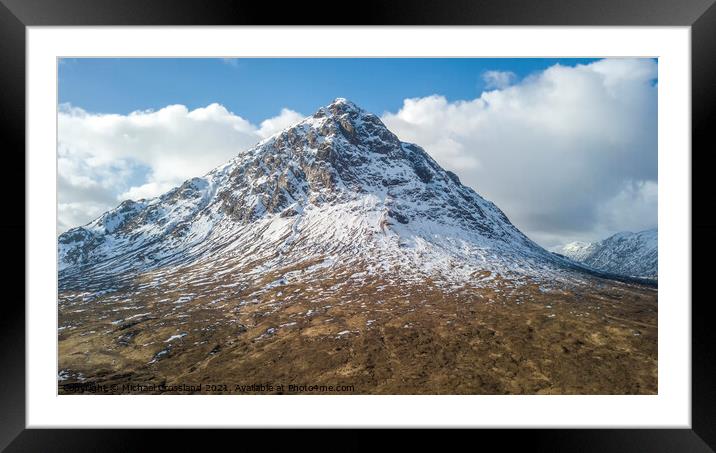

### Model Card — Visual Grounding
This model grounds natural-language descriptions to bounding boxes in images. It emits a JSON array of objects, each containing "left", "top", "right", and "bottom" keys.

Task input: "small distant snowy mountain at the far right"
[{"left": 556, "top": 228, "right": 658, "bottom": 279}]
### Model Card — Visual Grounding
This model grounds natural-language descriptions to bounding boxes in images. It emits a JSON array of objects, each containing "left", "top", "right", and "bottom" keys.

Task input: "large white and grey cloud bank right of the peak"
[{"left": 383, "top": 59, "right": 657, "bottom": 247}]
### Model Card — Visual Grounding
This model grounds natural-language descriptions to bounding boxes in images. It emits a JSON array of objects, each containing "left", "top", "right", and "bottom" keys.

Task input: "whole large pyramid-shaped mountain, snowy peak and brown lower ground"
[{"left": 58, "top": 99, "right": 657, "bottom": 393}]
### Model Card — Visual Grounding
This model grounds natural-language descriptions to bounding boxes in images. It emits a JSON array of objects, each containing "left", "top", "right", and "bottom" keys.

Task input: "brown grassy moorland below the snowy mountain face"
[{"left": 59, "top": 271, "right": 657, "bottom": 394}]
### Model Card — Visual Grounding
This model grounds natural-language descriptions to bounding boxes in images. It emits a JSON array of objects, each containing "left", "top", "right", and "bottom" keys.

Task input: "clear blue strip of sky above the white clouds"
[{"left": 59, "top": 58, "right": 594, "bottom": 123}]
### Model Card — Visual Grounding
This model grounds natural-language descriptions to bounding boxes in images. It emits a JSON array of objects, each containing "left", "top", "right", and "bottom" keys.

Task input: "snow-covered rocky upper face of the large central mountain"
[{"left": 59, "top": 99, "right": 588, "bottom": 286}]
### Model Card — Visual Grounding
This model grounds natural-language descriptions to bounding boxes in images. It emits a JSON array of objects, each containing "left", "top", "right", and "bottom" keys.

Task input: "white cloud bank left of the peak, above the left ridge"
[{"left": 57, "top": 104, "right": 302, "bottom": 232}]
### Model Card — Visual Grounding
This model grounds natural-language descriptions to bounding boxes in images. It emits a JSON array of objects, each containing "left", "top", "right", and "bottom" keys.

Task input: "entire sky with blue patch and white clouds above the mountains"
[{"left": 58, "top": 58, "right": 658, "bottom": 248}]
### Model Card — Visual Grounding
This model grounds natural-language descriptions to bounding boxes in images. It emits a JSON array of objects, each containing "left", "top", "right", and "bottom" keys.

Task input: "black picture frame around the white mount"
[{"left": 0, "top": 0, "right": 716, "bottom": 452}]
